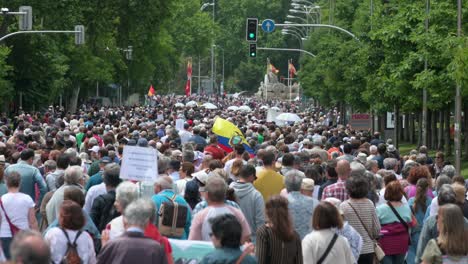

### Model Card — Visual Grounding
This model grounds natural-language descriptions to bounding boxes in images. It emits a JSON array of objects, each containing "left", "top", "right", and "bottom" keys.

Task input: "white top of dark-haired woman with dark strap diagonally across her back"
[{"left": 302, "top": 229, "right": 355, "bottom": 264}]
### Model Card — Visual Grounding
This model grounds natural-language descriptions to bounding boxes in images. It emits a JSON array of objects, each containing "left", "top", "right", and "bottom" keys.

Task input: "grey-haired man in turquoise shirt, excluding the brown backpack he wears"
[{"left": 151, "top": 176, "right": 192, "bottom": 239}]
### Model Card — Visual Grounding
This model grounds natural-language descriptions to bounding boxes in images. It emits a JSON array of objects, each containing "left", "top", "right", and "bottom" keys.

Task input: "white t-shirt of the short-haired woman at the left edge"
[{"left": 0, "top": 192, "right": 35, "bottom": 237}]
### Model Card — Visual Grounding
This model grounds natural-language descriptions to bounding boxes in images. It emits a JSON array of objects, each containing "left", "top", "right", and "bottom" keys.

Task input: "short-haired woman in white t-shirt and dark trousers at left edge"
[{"left": 0, "top": 172, "right": 39, "bottom": 259}]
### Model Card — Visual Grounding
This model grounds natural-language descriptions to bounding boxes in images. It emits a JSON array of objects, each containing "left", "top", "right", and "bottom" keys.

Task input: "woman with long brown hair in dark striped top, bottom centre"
[{"left": 255, "top": 195, "right": 303, "bottom": 264}]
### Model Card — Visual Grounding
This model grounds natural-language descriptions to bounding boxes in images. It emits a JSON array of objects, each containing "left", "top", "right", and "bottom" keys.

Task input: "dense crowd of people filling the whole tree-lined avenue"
[{"left": 0, "top": 96, "right": 468, "bottom": 264}]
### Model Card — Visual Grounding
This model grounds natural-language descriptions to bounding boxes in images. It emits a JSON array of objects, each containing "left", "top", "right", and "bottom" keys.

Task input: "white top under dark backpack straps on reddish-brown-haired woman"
[{"left": 44, "top": 227, "right": 96, "bottom": 264}]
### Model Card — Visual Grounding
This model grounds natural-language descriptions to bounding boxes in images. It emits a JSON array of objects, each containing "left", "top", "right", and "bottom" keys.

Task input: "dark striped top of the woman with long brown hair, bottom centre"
[{"left": 255, "top": 225, "right": 303, "bottom": 264}]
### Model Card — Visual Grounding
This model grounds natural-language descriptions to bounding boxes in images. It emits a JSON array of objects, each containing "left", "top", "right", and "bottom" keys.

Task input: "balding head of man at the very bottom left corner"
[{"left": 10, "top": 230, "right": 51, "bottom": 264}]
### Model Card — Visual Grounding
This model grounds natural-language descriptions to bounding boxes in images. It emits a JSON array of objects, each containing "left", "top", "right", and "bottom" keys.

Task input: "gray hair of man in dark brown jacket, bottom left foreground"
[{"left": 124, "top": 199, "right": 156, "bottom": 229}]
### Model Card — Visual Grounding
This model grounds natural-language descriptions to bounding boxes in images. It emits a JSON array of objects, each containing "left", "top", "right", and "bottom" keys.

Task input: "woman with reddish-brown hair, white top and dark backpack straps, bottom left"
[{"left": 44, "top": 200, "right": 96, "bottom": 264}]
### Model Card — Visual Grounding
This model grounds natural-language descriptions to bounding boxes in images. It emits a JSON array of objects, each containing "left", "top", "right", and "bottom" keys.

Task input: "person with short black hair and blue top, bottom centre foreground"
[{"left": 200, "top": 214, "right": 257, "bottom": 264}]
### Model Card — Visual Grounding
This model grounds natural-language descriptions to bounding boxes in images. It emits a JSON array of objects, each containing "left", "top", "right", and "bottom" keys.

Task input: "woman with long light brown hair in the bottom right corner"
[{"left": 422, "top": 204, "right": 468, "bottom": 264}]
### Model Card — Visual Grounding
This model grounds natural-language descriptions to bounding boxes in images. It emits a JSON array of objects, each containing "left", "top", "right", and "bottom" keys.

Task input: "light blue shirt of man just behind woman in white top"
[{"left": 288, "top": 192, "right": 319, "bottom": 240}]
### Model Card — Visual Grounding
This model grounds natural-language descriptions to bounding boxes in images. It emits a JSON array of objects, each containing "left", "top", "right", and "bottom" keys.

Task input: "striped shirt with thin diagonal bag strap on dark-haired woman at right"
[{"left": 341, "top": 199, "right": 380, "bottom": 255}]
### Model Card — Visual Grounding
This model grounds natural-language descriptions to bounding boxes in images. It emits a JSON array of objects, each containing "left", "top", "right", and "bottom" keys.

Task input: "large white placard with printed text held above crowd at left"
[{"left": 120, "top": 146, "right": 159, "bottom": 182}]
